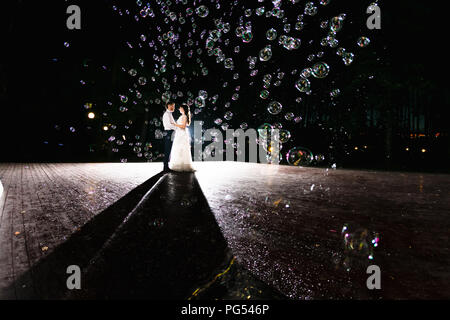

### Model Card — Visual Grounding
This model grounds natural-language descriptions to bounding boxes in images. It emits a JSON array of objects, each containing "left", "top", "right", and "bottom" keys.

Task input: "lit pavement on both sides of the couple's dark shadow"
[{"left": 0, "top": 162, "right": 450, "bottom": 299}]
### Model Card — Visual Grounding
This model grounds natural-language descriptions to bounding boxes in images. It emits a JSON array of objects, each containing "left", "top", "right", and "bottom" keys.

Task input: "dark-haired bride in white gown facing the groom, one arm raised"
[{"left": 169, "top": 105, "right": 195, "bottom": 172}]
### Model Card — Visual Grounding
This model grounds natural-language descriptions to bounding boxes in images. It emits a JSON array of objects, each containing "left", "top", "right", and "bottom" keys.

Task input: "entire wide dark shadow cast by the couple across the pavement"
[{"left": 6, "top": 173, "right": 285, "bottom": 300}]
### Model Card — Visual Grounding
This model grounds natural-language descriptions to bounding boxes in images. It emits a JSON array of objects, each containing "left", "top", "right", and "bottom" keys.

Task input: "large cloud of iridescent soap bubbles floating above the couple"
[{"left": 74, "top": 0, "right": 370, "bottom": 161}]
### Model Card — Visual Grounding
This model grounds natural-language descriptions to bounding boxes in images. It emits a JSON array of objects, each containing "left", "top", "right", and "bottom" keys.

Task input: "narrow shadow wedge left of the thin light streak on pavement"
[{"left": 0, "top": 173, "right": 163, "bottom": 299}]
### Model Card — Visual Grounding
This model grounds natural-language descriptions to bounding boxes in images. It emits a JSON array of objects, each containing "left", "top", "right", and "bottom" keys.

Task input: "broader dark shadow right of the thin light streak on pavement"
[{"left": 66, "top": 173, "right": 284, "bottom": 300}]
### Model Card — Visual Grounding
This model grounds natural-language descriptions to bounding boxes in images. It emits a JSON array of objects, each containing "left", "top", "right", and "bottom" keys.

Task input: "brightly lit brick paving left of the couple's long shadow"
[{"left": 0, "top": 163, "right": 162, "bottom": 298}]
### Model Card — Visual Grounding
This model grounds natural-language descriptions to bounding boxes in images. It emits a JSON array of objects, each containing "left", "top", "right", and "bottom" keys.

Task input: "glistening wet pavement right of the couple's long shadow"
[{"left": 196, "top": 162, "right": 450, "bottom": 299}]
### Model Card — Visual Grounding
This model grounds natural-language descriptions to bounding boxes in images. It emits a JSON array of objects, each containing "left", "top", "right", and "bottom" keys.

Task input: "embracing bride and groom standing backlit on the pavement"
[{"left": 163, "top": 101, "right": 195, "bottom": 172}]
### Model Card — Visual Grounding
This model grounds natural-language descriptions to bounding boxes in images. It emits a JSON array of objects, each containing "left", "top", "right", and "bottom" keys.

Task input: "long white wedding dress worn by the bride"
[{"left": 169, "top": 115, "right": 195, "bottom": 172}]
